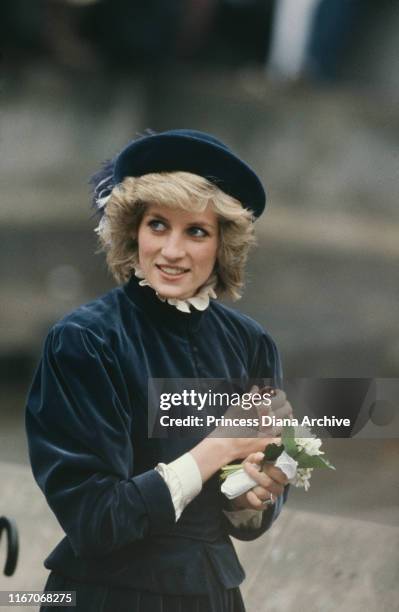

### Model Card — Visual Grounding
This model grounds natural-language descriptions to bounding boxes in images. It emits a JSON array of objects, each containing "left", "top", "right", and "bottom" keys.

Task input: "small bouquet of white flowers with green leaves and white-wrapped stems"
[{"left": 221, "top": 426, "right": 335, "bottom": 499}]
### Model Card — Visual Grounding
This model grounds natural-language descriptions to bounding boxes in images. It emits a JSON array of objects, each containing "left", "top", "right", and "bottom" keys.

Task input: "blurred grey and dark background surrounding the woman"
[{"left": 0, "top": 0, "right": 399, "bottom": 612}]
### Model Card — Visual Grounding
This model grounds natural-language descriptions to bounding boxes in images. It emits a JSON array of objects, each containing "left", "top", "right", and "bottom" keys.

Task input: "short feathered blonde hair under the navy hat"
[{"left": 97, "top": 172, "right": 255, "bottom": 300}]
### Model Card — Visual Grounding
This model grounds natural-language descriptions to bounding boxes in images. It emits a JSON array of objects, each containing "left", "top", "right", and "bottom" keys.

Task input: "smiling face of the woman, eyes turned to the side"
[{"left": 138, "top": 205, "right": 218, "bottom": 299}]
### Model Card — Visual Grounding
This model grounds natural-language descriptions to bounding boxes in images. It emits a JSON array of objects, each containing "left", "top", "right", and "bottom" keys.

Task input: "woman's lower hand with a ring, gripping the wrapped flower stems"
[{"left": 230, "top": 452, "right": 288, "bottom": 511}]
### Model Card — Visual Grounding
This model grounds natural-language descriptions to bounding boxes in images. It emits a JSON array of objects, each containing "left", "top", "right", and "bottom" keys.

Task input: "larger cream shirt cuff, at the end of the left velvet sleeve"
[{"left": 155, "top": 453, "right": 202, "bottom": 521}]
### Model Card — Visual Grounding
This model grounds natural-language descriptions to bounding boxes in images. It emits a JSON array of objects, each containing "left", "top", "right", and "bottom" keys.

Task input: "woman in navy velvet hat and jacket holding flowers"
[{"left": 27, "top": 130, "right": 290, "bottom": 612}]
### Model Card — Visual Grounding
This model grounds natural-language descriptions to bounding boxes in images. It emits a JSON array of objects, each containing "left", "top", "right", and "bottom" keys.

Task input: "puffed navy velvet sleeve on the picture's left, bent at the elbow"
[{"left": 26, "top": 323, "right": 175, "bottom": 557}]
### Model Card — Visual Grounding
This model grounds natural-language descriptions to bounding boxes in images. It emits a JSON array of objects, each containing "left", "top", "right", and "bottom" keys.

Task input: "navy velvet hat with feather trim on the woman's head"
[{"left": 92, "top": 130, "right": 266, "bottom": 217}]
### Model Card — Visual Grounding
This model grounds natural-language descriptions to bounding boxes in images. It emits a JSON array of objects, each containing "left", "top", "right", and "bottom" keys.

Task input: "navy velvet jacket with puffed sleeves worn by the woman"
[{"left": 26, "top": 278, "right": 286, "bottom": 594}]
